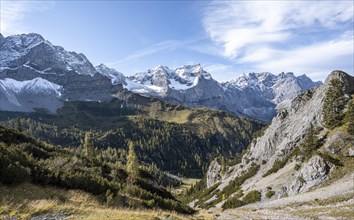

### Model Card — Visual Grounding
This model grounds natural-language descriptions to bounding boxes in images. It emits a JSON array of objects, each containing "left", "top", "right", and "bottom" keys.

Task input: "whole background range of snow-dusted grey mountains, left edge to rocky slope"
[{"left": 0, "top": 33, "right": 321, "bottom": 121}]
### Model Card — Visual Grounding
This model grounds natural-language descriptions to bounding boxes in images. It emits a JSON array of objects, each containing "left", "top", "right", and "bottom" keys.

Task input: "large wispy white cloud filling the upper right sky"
[{"left": 203, "top": 1, "right": 354, "bottom": 80}]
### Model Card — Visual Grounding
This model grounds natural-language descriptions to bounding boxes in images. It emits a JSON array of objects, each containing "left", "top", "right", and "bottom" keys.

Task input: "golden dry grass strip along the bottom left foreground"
[{"left": 0, "top": 183, "right": 207, "bottom": 220}]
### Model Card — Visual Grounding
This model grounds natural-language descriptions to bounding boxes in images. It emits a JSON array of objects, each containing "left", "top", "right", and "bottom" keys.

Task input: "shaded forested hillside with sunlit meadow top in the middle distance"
[{"left": 1, "top": 90, "right": 263, "bottom": 177}]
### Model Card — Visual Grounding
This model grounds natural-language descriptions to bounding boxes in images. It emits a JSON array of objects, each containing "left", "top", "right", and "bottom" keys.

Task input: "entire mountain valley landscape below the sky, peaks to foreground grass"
[{"left": 0, "top": 33, "right": 354, "bottom": 219}]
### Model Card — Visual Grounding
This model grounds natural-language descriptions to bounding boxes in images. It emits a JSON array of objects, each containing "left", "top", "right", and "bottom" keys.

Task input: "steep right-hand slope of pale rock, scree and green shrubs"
[{"left": 185, "top": 71, "right": 354, "bottom": 215}]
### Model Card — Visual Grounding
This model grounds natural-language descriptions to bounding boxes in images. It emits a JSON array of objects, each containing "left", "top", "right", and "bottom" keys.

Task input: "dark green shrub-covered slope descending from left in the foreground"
[{"left": 0, "top": 126, "right": 193, "bottom": 214}]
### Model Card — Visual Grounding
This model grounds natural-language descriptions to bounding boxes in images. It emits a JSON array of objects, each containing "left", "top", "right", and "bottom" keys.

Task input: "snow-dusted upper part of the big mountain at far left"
[{"left": 0, "top": 33, "right": 96, "bottom": 76}]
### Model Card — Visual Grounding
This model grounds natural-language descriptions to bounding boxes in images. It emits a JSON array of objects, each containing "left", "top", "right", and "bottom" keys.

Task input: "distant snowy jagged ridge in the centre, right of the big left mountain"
[{"left": 114, "top": 64, "right": 322, "bottom": 121}]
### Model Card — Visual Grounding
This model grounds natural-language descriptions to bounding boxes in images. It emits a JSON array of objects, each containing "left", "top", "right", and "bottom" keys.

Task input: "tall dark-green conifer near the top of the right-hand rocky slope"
[{"left": 322, "top": 79, "right": 345, "bottom": 129}]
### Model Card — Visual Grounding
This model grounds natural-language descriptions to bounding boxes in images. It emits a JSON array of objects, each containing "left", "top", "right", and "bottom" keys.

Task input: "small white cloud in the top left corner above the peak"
[{"left": 0, "top": 0, "right": 54, "bottom": 35}]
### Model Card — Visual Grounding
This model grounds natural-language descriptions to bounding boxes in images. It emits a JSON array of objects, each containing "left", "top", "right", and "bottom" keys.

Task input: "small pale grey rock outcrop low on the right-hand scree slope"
[{"left": 288, "top": 155, "right": 330, "bottom": 195}]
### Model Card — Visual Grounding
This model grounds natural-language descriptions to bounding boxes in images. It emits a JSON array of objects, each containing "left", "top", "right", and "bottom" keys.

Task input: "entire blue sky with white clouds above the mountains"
[{"left": 0, "top": 0, "right": 354, "bottom": 81}]
